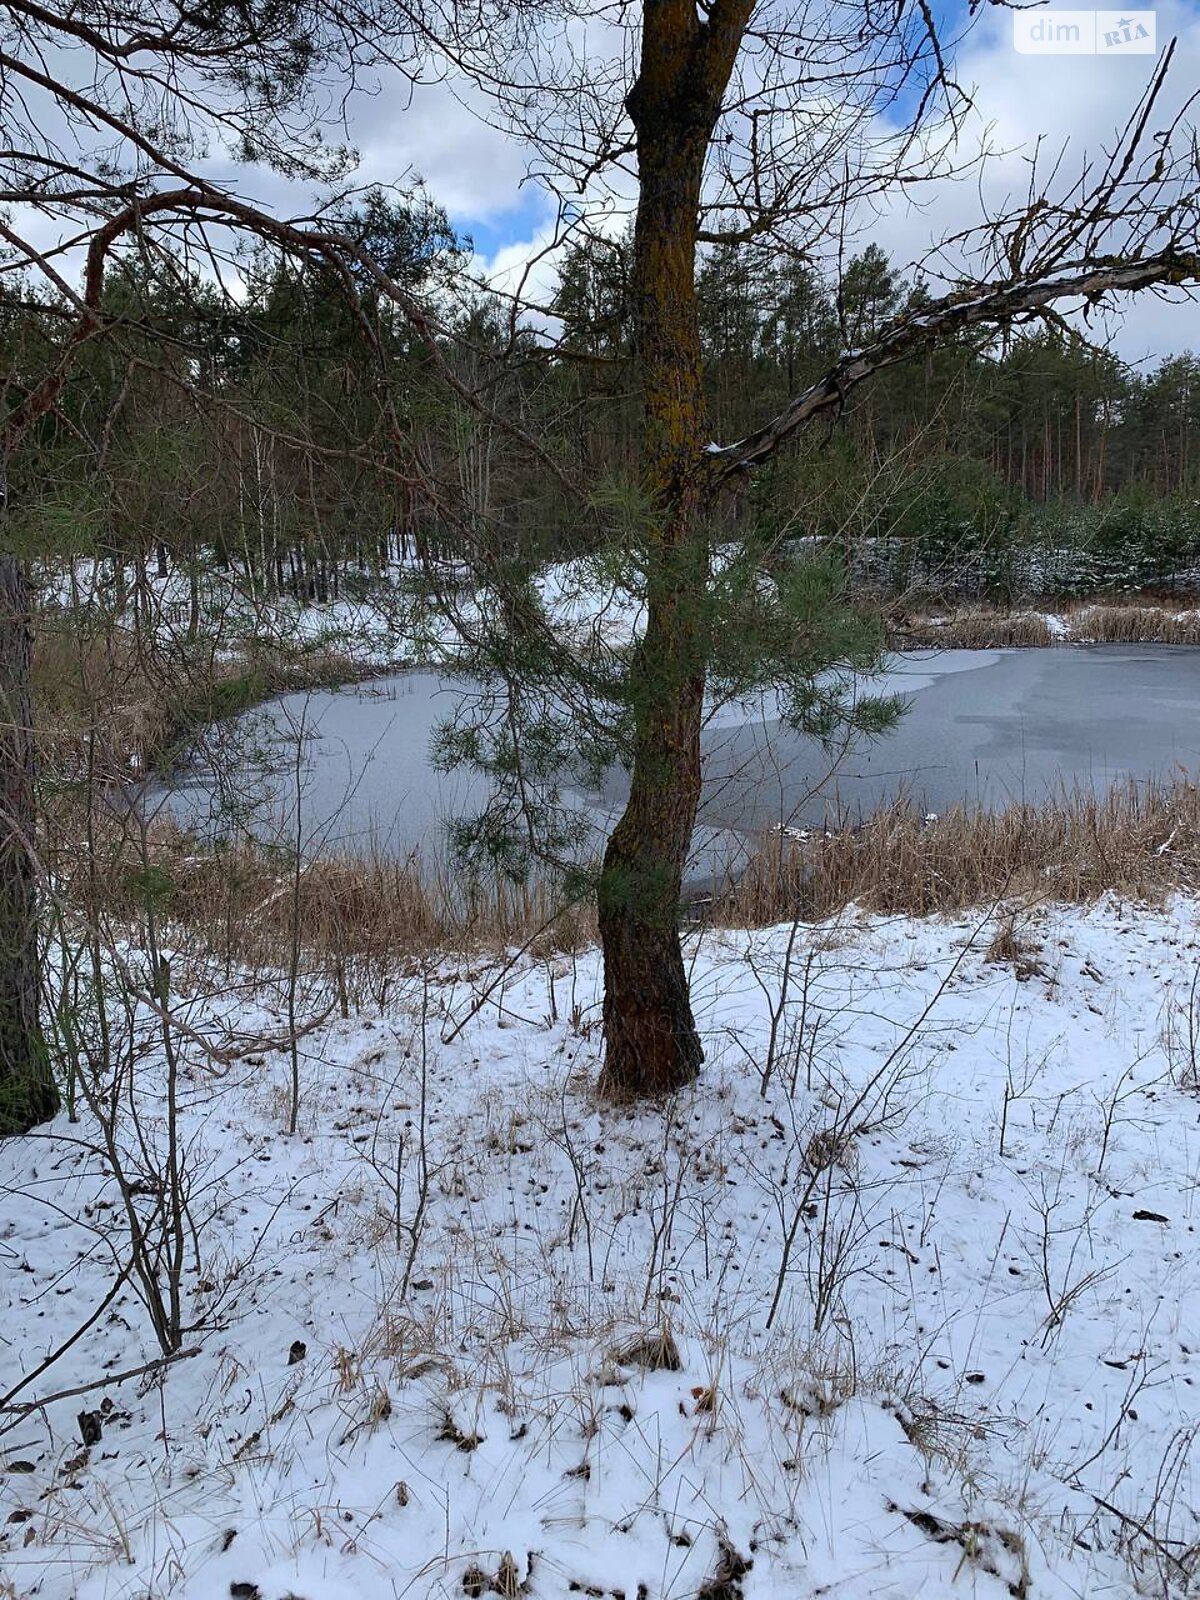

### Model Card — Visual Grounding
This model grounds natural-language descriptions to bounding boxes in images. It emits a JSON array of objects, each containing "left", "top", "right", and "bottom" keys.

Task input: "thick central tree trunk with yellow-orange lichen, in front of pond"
[{"left": 598, "top": 0, "right": 749, "bottom": 1099}]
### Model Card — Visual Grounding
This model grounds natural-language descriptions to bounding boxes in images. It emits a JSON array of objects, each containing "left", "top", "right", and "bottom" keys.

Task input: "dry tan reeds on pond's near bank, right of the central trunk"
[{"left": 714, "top": 779, "right": 1200, "bottom": 926}]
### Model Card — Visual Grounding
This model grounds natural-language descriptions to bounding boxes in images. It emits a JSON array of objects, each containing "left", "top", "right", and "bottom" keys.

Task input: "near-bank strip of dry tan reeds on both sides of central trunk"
[{"left": 63, "top": 778, "right": 1200, "bottom": 981}]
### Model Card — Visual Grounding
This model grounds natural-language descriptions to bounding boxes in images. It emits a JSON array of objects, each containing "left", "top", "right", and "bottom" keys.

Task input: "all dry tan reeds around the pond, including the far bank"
[{"left": 35, "top": 605, "right": 1200, "bottom": 982}]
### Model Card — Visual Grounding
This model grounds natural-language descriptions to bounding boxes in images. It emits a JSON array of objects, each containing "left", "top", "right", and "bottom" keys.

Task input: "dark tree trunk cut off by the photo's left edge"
[{"left": 0, "top": 550, "right": 58, "bottom": 1134}]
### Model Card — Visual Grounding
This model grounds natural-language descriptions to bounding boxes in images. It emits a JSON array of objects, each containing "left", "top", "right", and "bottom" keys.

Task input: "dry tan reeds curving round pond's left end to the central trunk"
[{"left": 34, "top": 614, "right": 595, "bottom": 989}]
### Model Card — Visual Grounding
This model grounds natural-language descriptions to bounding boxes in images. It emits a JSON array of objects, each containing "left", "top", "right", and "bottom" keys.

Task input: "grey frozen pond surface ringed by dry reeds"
[{"left": 146, "top": 645, "right": 1200, "bottom": 882}]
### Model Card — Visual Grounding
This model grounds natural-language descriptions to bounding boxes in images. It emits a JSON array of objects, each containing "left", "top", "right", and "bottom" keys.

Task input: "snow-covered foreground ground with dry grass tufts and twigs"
[{"left": 0, "top": 899, "right": 1200, "bottom": 1600}]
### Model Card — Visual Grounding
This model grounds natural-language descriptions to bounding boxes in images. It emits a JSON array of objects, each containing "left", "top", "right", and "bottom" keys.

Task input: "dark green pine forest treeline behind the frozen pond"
[{"left": 0, "top": 208, "right": 1200, "bottom": 618}]
